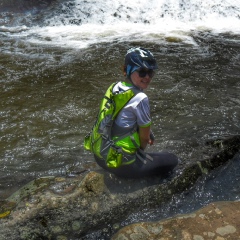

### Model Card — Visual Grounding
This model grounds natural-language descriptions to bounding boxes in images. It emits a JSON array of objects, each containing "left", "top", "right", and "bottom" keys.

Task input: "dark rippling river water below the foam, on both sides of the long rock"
[{"left": 0, "top": 1, "right": 240, "bottom": 237}]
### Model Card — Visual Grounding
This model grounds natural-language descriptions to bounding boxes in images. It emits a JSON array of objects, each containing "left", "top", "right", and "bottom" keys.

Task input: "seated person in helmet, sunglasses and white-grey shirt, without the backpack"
[{"left": 88, "top": 47, "right": 178, "bottom": 178}]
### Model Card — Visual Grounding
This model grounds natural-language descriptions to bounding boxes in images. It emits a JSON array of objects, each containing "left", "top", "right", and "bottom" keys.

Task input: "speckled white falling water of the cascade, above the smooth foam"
[{"left": 47, "top": 0, "right": 240, "bottom": 29}]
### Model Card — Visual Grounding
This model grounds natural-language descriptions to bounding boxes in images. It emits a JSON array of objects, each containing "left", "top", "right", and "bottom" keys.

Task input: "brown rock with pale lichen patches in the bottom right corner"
[{"left": 111, "top": 202, "right": 240, "bottom": 240}]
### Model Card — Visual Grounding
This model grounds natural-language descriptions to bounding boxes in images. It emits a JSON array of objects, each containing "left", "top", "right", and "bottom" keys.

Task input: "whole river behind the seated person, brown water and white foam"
[{"left": 0, "top": 0, "right": 240, "bottom": 236}]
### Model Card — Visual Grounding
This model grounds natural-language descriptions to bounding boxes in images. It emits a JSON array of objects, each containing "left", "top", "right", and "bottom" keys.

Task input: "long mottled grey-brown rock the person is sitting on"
[{"left": 0, "top": 136, "right": 240, "bottom": 240}]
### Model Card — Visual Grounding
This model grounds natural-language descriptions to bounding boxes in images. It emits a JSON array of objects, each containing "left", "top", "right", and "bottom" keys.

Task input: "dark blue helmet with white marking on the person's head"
[{"left": 124, "top": 47, "right": 158, "bottom": 77}]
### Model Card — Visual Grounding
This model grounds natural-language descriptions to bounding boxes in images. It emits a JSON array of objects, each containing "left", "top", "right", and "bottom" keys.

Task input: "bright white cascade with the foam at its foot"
[{"left": 7, "top": 0, "right": 240, "bottom": 48}]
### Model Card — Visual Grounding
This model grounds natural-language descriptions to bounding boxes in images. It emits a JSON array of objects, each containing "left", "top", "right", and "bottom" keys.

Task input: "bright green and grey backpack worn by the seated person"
[{"left": 84, "top": 83, "right": 140, "bottom": 168}]
